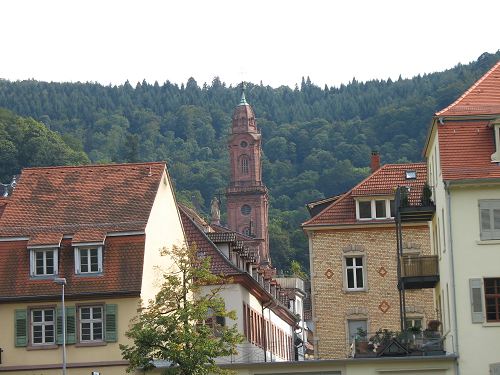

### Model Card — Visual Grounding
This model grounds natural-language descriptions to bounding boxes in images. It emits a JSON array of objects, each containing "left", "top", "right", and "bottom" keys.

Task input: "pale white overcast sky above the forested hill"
[{"left": 0, "top": 0, "right": 500, "bottom": 87}]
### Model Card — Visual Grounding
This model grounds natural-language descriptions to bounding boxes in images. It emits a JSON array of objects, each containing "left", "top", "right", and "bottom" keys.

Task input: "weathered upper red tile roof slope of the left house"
[{"left": 0, "top": 163, "right": 165, "bottom": 243}]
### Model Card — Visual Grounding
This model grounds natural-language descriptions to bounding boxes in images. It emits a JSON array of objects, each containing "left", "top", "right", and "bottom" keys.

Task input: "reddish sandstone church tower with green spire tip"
[{"left": 226, "top": 84, "right": 270, "bottom": 265}]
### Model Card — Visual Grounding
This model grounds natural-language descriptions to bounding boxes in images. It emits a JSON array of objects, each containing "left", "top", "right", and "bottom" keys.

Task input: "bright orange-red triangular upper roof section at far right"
[{"left": 436, "top": 61, "right": 500, "bottom": 116}]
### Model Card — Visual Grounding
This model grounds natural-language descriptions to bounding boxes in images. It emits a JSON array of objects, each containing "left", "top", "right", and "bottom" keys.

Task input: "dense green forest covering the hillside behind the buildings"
[{"left": 0, "top": 51, "right": 500, "bottom": 269}]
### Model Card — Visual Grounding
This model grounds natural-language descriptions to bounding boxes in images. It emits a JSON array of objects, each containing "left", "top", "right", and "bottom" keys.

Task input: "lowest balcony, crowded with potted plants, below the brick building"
[{"left": 350, "top": 330, "right": 446, "bottom": 358}]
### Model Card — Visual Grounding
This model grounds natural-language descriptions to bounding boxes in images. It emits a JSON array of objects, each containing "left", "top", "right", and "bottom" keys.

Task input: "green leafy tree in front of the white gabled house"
[{"left": 120, "top": 246, "right": 242, "bottom": 375}]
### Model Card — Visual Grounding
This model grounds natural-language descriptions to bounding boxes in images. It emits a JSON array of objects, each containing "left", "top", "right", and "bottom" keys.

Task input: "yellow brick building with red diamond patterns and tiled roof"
[{"left": 303, "top": 163, "right": 436, "bottom": 359}]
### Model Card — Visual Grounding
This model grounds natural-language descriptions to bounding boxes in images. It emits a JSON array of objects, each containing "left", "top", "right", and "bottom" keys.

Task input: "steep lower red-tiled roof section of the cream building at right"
[{"left": 437, "top": 120, "right": 500, "bottom": 180}]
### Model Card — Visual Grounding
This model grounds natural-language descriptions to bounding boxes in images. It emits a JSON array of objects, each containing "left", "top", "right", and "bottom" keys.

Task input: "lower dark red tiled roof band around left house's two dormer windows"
[{"left": 0, "top": 235, "right": 145, "bottom": 301}]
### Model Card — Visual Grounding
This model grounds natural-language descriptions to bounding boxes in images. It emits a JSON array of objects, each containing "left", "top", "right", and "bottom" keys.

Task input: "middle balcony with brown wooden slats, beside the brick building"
[{"left": 399, "top": 255, "right": 439, "bottom": 289}]
